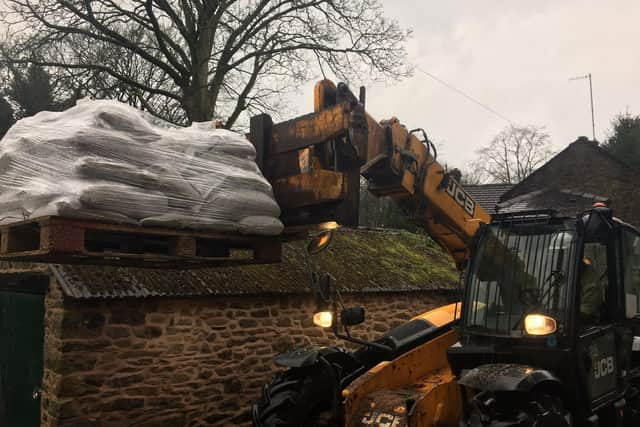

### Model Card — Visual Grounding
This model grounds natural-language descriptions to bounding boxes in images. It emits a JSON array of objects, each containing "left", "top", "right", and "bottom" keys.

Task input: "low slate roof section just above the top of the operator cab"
[{"left": 496, "top": 188, "right": 609, "bottom": 216}]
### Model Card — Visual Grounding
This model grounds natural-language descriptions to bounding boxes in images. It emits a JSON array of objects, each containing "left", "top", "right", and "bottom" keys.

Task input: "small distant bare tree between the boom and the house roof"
[{"left": 474, "top": 125, "right": 553, "bottom": 184}]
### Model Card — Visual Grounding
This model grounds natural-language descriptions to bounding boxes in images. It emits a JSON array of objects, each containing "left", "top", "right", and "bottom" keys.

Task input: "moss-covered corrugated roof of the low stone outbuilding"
[{"left": 0, "top": 229, "right": 458, "bottom": 299}]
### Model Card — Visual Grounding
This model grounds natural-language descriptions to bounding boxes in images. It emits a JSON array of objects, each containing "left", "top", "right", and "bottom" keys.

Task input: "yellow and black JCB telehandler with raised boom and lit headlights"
[{"left": 250, "top": 80, "right": 640, "bottom": 427}]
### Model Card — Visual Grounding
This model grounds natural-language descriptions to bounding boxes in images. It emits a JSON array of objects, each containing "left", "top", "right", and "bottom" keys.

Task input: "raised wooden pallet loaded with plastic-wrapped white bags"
[{"left": 0, "top": 100, "right": 283, "bottom": 267}]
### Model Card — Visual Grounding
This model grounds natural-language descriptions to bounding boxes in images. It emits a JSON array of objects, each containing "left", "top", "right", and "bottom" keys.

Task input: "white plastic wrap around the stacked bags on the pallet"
[{"left": 0, "top": 100, "right": 283, "bottom": 235}]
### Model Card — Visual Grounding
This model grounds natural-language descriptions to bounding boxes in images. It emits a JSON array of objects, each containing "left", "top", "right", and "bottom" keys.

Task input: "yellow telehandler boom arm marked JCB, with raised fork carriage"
[{"left": 250, "top": 80, "right": 491, "bottom": 268}]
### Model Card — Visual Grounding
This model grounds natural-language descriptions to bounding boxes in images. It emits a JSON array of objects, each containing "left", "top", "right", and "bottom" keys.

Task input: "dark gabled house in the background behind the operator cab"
[{"left": 465, "top": 137, "right": 640, "bottom": 227}]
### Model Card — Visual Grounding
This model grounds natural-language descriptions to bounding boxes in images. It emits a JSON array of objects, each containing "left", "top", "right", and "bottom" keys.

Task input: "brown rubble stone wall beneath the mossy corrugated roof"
[{"left": 42, "top": 283, "right": 450, "bottom": 427}]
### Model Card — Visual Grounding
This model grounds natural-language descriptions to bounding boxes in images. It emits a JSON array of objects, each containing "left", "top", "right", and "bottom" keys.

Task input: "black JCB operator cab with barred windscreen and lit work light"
[{"left": 448, "top": 206, "right": 640, "bottom": 421}]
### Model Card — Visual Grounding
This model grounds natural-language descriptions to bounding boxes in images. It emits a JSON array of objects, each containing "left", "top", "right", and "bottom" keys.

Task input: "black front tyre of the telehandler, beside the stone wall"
[{"left": 252, "top": 366, "right": 336, "bottom": 427}]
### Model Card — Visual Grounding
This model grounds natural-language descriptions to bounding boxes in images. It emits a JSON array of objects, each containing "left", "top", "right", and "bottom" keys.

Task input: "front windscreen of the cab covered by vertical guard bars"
[{"left": 463, "top": 212, "right": 579, "bottom": 339}]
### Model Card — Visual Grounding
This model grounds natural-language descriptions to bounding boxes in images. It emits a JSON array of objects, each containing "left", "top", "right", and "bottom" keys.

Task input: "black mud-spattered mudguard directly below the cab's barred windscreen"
[{"left": 458, "top": 363, "right": 562, "bottom": 392}]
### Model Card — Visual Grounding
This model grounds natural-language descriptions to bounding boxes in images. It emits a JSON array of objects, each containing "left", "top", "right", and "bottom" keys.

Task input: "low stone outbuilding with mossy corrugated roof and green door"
[{"left": 0, "top": 230, "right": 458, "bottom": 427}]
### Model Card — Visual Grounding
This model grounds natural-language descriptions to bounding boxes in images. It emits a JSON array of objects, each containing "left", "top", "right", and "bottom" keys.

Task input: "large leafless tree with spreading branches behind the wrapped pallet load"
[{"left": 3, "top": 0, "right": 410, "bottom": 127}]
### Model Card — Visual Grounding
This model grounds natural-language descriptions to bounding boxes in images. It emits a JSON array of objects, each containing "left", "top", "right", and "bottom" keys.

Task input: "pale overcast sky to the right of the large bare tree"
[{"left": 294, "top": 0, "right": 640, "bottom": 171}]
